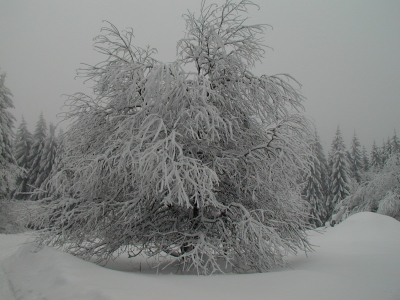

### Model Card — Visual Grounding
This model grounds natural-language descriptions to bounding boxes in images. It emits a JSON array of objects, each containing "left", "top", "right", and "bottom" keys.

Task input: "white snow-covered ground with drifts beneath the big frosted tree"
[{"left": 0, "top": 213, "right": 400, "bottom": 300}]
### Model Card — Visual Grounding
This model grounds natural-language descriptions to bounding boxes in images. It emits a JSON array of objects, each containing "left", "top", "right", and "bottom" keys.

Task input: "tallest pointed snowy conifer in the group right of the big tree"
[{"left": 329, "top": 126, "right": 349, "bottom": 214}]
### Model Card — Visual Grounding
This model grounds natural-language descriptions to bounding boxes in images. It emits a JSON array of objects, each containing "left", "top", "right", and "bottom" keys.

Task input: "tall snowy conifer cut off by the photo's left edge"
[{"left": 0, "top": 74, "right": 17, "bottom": 198}]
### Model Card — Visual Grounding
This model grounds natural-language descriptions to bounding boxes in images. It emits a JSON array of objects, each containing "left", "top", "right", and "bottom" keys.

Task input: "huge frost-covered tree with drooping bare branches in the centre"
[{"left": 32, "top": 0, "right": 312, "bottom": 274}]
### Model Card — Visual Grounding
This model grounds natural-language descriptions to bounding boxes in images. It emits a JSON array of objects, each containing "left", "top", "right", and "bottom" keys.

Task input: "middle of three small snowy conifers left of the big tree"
[{"left": 27, "top": 113, "right": 47, "bottom": 192}]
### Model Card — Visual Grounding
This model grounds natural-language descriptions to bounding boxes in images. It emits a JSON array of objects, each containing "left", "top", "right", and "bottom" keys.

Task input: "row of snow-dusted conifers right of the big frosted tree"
[{"left": 302, "top": 127, "right": 400, "bottom": 227}]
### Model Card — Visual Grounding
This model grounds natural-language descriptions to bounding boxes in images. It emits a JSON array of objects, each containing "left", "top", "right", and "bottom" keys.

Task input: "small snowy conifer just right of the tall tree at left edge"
[{"left": 14, "top": 116, "right": 33, "bottom": 197}]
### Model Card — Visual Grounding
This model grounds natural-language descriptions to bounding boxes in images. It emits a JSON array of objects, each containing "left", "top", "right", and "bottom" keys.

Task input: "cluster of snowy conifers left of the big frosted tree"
[{"left": 0, "top": 74, "right": 62, "bottom": 200}]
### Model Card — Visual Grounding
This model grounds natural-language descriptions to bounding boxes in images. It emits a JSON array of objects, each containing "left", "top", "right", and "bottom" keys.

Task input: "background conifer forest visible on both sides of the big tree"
[{"left": 2, "top": 91, "right": 400, "bottom": 227}]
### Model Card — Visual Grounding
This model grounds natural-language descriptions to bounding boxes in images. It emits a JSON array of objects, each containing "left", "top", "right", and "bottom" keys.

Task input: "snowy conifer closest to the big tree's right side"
[{"left": 303, "top": 133, "right": 327, "bottom": 227}]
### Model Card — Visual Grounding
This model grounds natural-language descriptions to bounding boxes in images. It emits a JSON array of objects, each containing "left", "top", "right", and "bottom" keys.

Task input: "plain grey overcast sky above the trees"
[{"left": 0, "top": 0, "right": 400, "bottom": 151}]
